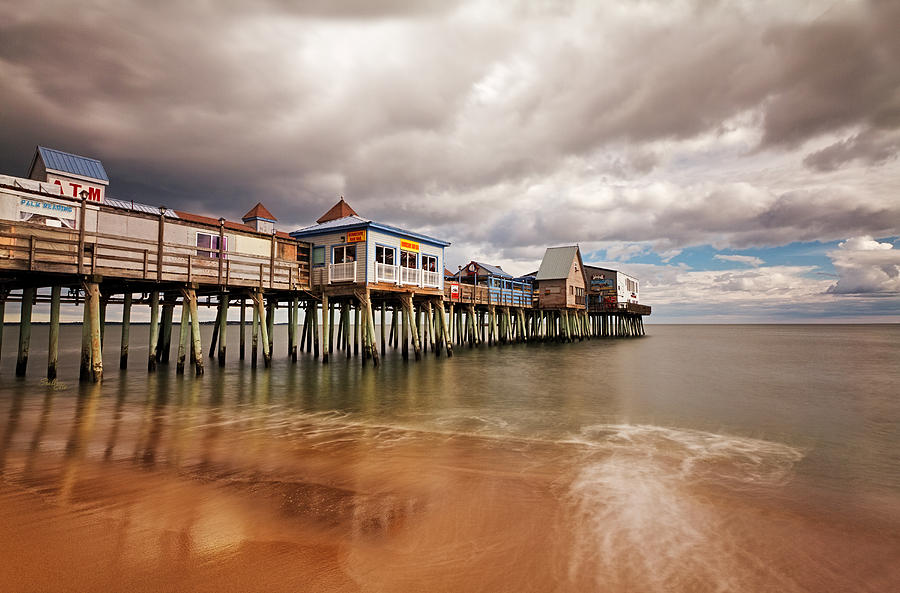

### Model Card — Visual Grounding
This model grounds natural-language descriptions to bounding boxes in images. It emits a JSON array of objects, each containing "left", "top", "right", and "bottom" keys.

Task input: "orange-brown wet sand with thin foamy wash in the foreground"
[{"left": 0, "top": 389, "right": 900, "bottom": 592}]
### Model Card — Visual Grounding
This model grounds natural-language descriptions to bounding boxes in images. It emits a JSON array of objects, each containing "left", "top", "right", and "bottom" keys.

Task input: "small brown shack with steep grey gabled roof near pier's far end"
[{"left": 535, "top": 245, "right": 585, "bottom": 309}]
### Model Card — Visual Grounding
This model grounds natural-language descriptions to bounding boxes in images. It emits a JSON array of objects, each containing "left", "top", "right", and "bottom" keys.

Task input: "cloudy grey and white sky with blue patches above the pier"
[{"left": 0, "top": 0, "right": 900, "bottom": 323}]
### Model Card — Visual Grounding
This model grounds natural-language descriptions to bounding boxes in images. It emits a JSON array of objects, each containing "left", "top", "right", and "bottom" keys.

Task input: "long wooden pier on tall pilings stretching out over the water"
[{"left": 0, "top": 166, "right": 650, "bottom": 382}]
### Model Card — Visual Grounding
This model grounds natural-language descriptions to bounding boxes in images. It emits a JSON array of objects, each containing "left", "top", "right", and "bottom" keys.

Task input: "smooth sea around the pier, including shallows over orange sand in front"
[{"left": 0, "top": 324, "right": 900, "bottom": 593}]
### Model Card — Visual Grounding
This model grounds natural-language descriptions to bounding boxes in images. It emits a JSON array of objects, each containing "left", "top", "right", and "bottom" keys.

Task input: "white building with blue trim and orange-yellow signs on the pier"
[{"left": 290, "top": 197, "right": 450, "bottom": 295}]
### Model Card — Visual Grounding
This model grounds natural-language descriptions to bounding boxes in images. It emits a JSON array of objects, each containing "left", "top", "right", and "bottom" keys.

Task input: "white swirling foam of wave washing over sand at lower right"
[{"left": 564, "top": 424, "right": 804, "bottom": 591}]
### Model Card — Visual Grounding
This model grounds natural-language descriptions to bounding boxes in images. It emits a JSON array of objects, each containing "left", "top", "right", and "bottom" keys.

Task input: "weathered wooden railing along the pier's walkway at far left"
[{"left": 0, "top": 223, "right": 309, "bottom": 290}]
